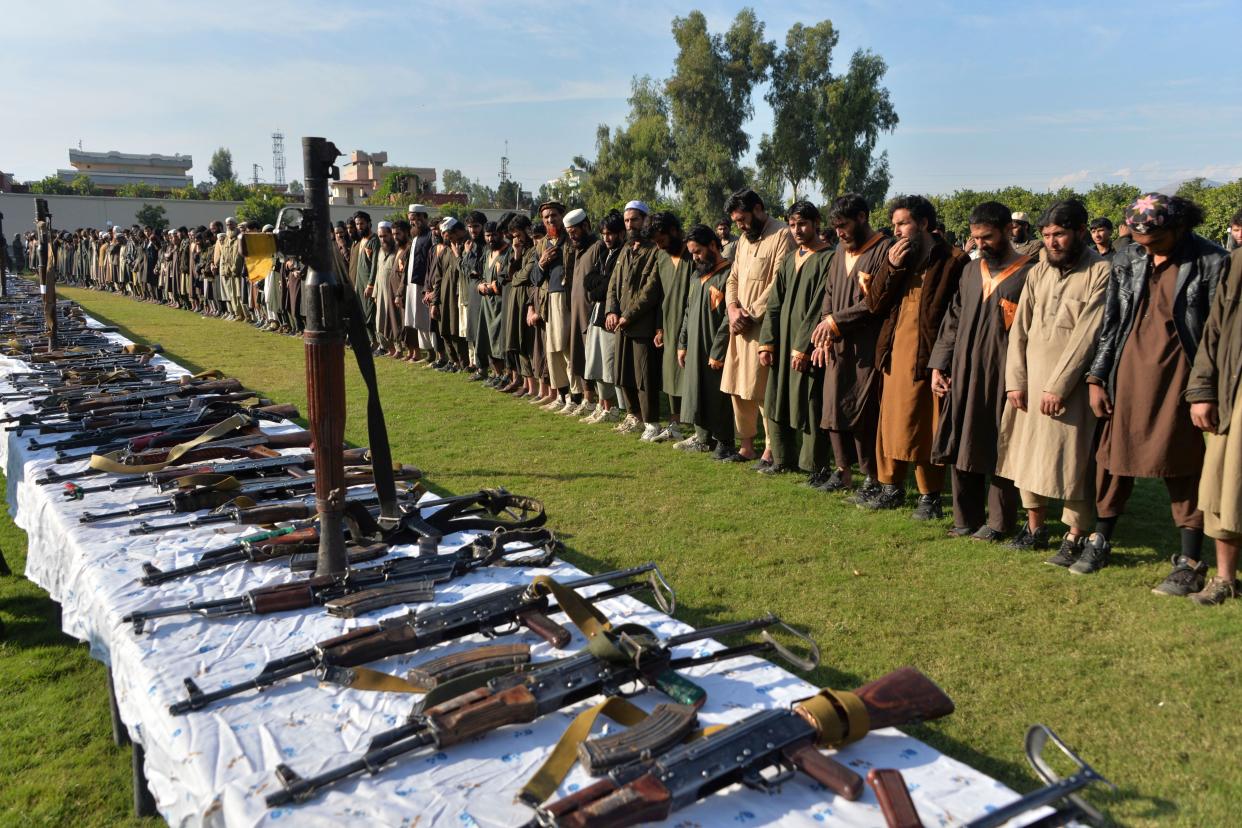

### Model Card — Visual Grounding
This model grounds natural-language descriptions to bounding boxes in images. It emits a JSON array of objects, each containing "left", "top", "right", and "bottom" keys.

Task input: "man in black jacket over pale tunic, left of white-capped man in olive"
[{"left": 579, "top": 210, "right": 625, "bottom": 425}]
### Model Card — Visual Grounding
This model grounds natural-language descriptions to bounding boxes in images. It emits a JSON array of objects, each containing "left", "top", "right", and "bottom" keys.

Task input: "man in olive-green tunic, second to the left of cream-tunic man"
[{"left": 647, "top": 212, "right": 692, "bottom": 443}]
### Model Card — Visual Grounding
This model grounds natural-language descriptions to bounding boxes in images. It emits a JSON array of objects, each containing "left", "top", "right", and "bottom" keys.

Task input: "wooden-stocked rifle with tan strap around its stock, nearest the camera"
[{"left": 527, "top": 667, "right": 954, "bottom": 828}]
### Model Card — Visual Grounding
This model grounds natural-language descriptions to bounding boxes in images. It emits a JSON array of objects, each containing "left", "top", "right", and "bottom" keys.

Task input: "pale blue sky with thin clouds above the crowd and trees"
[{"left": 0, "top": 0, "right": 1242, "bottom": 198}]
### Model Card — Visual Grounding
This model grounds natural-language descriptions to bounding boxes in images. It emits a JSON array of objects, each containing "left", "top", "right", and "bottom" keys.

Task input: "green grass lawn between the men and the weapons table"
[{"left": 0, "top": 283, "right": 1242, "bottom": 826}]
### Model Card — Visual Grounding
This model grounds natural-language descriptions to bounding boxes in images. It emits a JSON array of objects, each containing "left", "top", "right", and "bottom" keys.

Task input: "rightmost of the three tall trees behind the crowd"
[{"left": 812, "top": 50, "right": 897, "bottom": 205}]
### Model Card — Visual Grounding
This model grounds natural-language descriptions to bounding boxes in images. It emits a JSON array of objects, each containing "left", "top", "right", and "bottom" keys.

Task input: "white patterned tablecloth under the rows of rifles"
[{"left": 0, "top": 322, "right": 1038, "bottom": 827}]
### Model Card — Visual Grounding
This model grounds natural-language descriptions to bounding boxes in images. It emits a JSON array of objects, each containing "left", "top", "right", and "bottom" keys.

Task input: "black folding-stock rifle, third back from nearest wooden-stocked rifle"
[{"left": 169, "top": 564, "right": 673, "bottom": 716}]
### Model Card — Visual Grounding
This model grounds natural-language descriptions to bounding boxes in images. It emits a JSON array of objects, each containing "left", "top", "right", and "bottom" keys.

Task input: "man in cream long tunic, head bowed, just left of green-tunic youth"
[{"left": 720, "top": 189, "right": 794, "bottom": 470}]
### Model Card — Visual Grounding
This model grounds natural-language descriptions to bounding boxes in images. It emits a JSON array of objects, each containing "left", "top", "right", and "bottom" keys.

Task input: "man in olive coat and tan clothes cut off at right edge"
[{"left": 1186, "top": 243, "right": 1242, "bottom": 606}]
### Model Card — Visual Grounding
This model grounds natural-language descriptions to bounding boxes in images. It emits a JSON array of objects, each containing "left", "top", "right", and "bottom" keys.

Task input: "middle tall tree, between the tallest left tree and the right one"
[{"left": 755, "top": 20, "right": 840, "bottom": 204}]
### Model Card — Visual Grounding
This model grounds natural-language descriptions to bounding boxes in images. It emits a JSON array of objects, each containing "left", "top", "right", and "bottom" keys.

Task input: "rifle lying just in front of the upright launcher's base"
[{"left": 122, "top": 529, "right": 559, "bottom": 634}]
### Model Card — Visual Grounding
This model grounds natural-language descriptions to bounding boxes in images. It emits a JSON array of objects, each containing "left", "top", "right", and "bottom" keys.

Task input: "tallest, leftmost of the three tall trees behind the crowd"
[{"left": 664, "top": 9, "right": 776, "bottom": 221}]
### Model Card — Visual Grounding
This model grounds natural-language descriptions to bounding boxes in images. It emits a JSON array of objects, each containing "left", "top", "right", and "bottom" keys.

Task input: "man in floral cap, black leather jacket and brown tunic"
[{"left": 1069, "top": 192, "right": 1228, "bottom": 583}]
